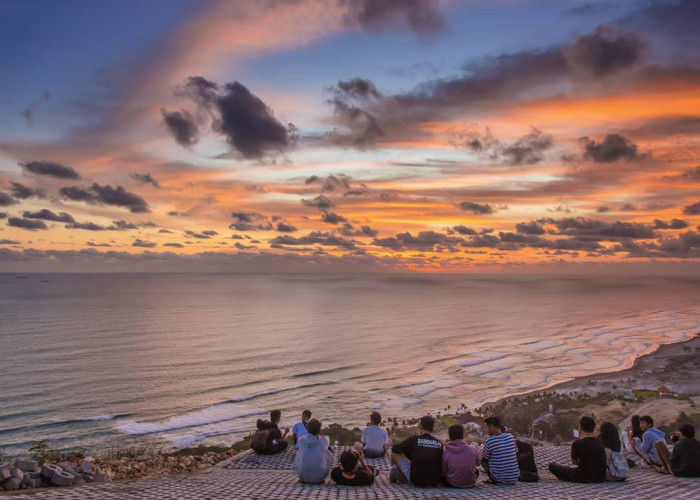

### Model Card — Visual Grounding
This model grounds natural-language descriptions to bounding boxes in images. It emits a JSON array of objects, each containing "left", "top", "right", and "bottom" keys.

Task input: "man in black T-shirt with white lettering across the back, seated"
[{"left": 389, "top": 416, "right": 442, "bottom": 486}]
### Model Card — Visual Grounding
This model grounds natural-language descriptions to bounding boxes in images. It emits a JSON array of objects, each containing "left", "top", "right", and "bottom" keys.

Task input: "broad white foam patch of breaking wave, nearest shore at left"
[{"left": 117, "top": 405, "right": 266, "bottom": 434}]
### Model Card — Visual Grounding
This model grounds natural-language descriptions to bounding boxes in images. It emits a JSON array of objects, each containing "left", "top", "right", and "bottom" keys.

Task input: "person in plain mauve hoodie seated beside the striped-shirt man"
[{"left": 442, "top": 424, "right": 479, "bottom": 488}]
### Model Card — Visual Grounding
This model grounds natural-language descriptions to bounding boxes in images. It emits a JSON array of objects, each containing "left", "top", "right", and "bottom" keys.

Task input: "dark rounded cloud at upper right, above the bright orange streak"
[{"left": 564, "top": 25, "right": 647, "bottom": 78}]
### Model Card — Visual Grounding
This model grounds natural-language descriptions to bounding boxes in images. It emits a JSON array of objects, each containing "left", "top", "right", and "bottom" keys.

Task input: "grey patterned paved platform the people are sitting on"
[{"left": 0, "top": 446, "right": 700, "bottom": 500}]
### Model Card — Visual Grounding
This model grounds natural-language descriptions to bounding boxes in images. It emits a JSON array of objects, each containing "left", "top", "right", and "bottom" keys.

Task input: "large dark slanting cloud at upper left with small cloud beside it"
[{"left": 174, "top": 76, "right": 297, "bottom": 158}]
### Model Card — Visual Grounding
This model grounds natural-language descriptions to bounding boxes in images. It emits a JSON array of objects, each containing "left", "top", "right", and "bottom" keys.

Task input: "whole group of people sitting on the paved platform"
[{"left": 251, "top": 410, "right": 700, "bottom": 488}]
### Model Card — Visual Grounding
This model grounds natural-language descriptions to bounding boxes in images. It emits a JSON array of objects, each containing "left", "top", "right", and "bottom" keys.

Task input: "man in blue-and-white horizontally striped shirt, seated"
[{"left": 481, "top": 416, "right": 520, "bottom": 484}]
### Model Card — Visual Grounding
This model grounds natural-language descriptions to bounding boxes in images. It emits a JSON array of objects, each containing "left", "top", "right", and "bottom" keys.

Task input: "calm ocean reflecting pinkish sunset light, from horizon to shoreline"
[{"left": 0, "top": 274, "right": 700, "bottom": 455}]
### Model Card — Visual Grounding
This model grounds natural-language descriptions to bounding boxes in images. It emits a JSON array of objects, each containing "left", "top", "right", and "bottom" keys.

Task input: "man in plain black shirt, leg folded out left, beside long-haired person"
[{"left": 549, "top": 417, "right": 608, "bottom": 483}]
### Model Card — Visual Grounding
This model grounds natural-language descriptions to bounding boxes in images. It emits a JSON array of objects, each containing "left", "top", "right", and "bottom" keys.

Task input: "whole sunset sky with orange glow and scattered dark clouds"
[{"left": 0, "top": 0, "right": 700, "bottom": 272}]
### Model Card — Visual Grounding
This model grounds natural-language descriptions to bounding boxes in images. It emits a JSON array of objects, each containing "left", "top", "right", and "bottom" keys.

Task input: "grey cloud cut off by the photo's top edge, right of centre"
[{"left": 338, "top": 0, "right": 447, "bottom": 37}]
